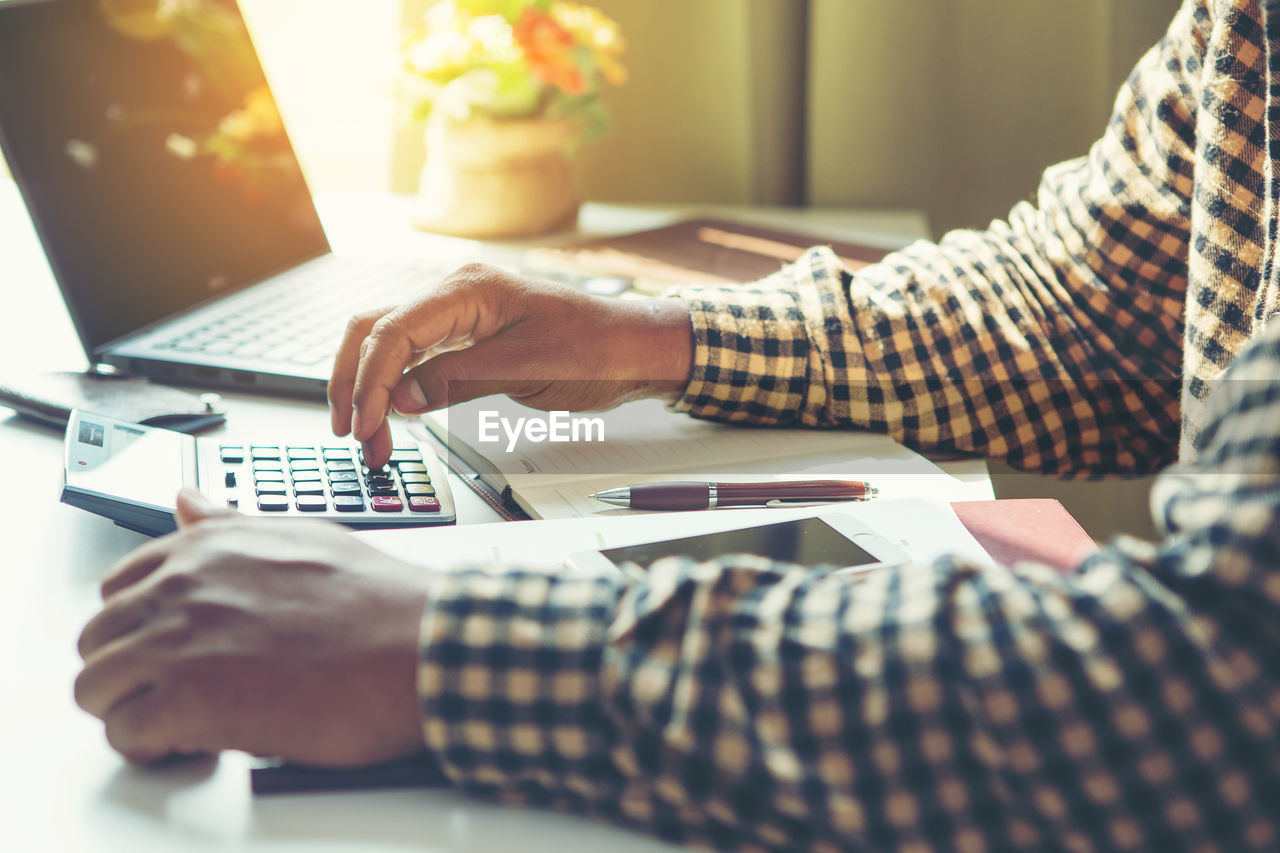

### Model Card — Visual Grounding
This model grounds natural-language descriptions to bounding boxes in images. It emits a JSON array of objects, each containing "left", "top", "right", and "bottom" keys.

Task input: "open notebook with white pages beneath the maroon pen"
[{"left": 420, "top": 397, "right": 956, "bottom": 519}]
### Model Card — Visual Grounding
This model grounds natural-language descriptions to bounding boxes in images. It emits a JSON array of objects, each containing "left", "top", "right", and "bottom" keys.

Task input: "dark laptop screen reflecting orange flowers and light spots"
[{"left": 0, "top": 0, "right": 329, "bottom": 357}]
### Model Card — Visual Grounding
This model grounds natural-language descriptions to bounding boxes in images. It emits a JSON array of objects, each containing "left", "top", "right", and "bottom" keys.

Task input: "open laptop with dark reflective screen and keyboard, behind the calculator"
[{"left": 0, "top": 0, "right": 448, "bottom": 398}]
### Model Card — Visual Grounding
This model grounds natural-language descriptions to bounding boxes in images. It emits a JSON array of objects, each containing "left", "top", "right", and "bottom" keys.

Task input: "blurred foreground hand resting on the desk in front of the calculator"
[{"left": 76, "top": 493, "right": 428, "bottom": 767}]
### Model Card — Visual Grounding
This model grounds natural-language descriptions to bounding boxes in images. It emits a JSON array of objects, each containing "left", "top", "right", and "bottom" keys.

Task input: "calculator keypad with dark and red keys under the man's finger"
[{"left": 207, "top": 443, "right": 452, "bottom": 526}]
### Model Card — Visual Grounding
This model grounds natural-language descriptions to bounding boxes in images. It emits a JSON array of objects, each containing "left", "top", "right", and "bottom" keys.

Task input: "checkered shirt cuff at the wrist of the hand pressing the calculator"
[{"left": 667, "top": 248, "right": 842, "bottom": 423}]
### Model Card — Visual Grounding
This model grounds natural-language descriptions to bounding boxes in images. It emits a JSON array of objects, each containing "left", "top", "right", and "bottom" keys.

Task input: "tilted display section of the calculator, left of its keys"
[{"left": 67, "top": 414, "right": 186, "bottom": 510}]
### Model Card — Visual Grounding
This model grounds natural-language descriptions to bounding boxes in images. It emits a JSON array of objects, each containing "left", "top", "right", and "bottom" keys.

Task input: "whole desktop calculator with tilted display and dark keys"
[{"left": 61, "top": 410, "right": 457, "bottom": 535}]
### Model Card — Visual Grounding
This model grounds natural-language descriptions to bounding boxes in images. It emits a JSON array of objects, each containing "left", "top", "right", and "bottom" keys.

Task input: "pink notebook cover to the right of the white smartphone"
[{"left": 951, "top": 498, "right": 1098, "bottom": 571}]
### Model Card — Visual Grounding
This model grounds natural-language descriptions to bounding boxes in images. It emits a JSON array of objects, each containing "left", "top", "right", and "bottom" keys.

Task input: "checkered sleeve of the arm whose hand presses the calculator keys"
[{"left": 673, "top": 3, "right": 1207, "bottom": 474}]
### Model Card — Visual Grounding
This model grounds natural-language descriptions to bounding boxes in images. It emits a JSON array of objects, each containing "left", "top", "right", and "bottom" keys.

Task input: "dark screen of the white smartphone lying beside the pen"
[{"left": 600, "top": 519, "right": 878, "bottom": 567}]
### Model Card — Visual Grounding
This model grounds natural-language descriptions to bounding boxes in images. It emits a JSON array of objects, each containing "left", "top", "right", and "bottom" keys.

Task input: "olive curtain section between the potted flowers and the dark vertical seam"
[{"left": 560, "top": 0, "right": 808, "bottom": 204}]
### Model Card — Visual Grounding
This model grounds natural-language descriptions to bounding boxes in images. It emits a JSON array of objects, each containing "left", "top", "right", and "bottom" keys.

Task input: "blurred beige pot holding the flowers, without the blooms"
[{"left": 413, "top": 112, "right": 581, "bottom": 238}]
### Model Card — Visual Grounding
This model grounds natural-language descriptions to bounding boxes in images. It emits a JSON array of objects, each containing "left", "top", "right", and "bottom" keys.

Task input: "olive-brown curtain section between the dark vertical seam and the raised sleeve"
[{"left": 806, "top": 0, "right": 1179, "bottom": 233}]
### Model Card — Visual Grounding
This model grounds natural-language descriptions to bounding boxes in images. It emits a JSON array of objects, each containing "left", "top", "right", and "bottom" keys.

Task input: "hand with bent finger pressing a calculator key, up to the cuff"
[{"left": 329, "top": 264, "right": 692, "bottom": 467}]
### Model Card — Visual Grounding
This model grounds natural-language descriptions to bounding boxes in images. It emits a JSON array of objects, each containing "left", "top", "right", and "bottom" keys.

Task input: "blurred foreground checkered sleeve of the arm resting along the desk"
[{"left": 419, "top": 324, "right": 1280, "bottom": 850}]
